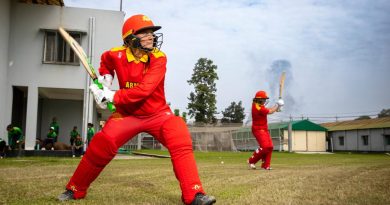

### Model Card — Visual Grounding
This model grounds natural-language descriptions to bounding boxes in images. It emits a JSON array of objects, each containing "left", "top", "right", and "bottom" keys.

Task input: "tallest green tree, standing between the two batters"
[{"left": 187, "top": 58, "right": 218, "bottom": 123}]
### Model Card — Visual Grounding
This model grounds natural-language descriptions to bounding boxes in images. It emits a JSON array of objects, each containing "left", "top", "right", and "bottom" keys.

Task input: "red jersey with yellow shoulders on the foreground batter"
[{"left": 99, "top": 46, "right": 168, "bottom": 116}]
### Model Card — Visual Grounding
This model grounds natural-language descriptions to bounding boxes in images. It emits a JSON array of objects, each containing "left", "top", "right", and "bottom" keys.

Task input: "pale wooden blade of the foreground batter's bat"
[{"left": 58, "top": 27, "right": 97, "bottom": 80}]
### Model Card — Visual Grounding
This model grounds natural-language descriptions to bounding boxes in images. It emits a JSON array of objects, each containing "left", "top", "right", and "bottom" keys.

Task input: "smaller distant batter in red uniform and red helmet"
[{"left": 248, "top": 90, "right": 284, "bottom": 170}]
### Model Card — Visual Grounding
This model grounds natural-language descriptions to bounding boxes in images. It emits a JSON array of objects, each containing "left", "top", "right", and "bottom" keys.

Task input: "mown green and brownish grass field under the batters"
[{"left": 0, "top": 150, "right": 390, "bottom": 205}]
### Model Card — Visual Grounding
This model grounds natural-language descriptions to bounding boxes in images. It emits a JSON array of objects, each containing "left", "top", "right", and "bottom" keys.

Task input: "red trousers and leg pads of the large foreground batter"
[{"left": 66, "top": 109, "right": 204, "bottom": 204}]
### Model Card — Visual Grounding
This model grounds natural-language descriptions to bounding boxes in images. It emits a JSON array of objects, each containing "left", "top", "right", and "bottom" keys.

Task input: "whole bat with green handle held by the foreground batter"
[{"left": 58, "top": 27, "right": 116, "bottom": 112}]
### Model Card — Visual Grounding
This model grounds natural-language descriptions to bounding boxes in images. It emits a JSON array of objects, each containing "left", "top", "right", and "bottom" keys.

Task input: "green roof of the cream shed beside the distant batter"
[{"left": 268, "top": 120, "right": 327, "bottom": 131}]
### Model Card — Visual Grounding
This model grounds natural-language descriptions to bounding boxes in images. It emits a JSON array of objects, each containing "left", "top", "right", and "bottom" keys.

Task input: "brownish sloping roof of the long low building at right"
[{"left": 321, "top": 117, "right": 390, "bottom": 131}]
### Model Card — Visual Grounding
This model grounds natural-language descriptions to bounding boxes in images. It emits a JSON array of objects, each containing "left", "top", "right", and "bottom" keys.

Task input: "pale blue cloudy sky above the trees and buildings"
[{"left": 64, "top": 0, "right": 390, "bottom": 122}]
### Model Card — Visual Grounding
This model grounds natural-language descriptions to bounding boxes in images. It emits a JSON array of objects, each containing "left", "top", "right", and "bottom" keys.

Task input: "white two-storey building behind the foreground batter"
[{"left": 0, "top": 0, "right": 125, "bottom": 150}]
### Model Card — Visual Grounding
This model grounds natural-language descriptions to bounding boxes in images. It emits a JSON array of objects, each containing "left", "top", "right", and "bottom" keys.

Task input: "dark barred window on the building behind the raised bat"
[{"left": 43, "top": 30, "right": 81, "bottom": 65}]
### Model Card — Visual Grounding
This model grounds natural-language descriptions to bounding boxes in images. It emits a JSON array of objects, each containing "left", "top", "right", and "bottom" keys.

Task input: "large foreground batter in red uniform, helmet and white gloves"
[{"left": 58, "top": 15, "right": 216, "bottom": 205}]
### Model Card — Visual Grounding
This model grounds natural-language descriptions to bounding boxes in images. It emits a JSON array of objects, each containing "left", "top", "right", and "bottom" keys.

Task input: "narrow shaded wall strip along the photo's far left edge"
[{"left": 0, "top": 0, "right": 11, "bottom": 141}]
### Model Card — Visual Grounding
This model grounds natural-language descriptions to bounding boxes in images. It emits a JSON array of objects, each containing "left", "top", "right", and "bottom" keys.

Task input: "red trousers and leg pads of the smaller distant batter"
[{"left": 249, "top": 127, "right": 274, "bottom": 169}]
